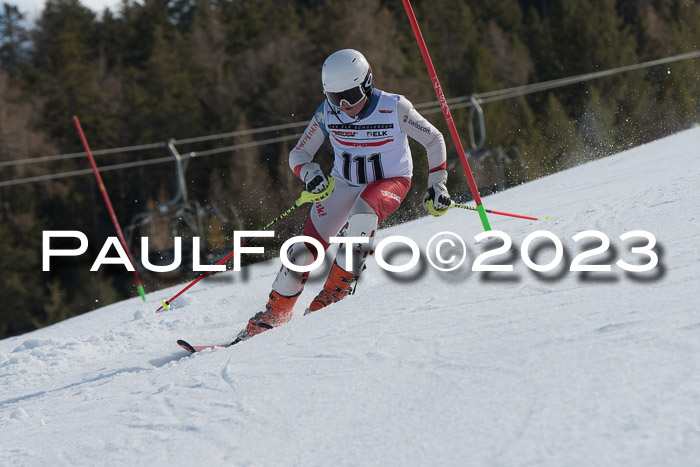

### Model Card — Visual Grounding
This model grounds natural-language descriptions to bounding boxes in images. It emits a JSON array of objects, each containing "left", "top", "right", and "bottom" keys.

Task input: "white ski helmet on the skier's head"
[{"left": 321, "top": 49, "right": 373, "bottom": 107}]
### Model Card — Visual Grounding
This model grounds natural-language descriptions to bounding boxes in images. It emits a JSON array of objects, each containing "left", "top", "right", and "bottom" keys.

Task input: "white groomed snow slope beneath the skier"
[{"left": 0, "top": 128, "right": 700, "bottom": 466}]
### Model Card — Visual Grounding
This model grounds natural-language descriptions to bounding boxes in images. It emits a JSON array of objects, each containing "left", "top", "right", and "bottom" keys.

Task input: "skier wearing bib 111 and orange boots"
[{"left": 233, "top": 49, "right": 451, "bottom": 344}]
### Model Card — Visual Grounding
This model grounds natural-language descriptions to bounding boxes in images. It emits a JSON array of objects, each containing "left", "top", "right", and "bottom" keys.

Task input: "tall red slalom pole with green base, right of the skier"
[{"left": 403, "top": 0, "right": 491, "bottom": 230}]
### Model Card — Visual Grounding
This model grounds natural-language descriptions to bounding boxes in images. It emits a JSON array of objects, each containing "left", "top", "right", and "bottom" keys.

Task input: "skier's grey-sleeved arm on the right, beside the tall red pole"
[{"left": 397, "top": 96, "right": 447, "bottom": 186}]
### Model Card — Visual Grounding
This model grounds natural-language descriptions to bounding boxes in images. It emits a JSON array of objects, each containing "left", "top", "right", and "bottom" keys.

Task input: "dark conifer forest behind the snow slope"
[{"left": 0, "top": 0, "right": 700, "bottom": 338}]
